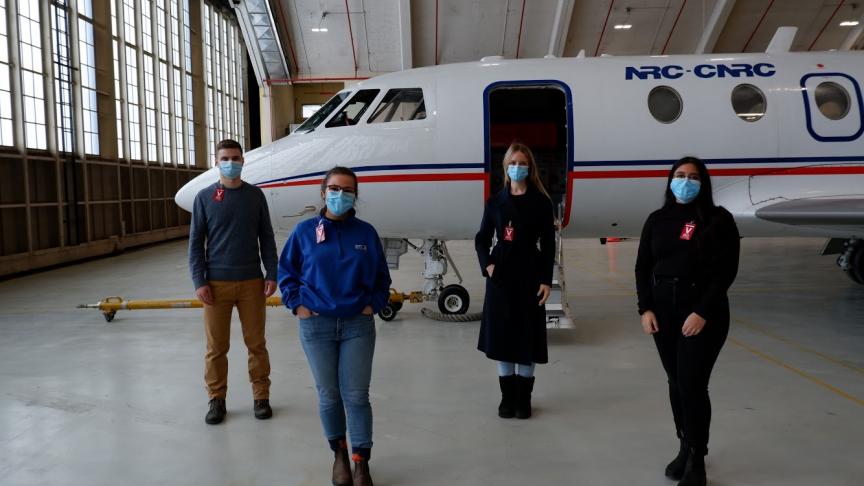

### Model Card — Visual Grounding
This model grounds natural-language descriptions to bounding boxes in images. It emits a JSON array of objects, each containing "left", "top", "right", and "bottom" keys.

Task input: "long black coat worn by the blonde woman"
[{"left": 474, "top": 184, "right": 555, "bottom": 364}]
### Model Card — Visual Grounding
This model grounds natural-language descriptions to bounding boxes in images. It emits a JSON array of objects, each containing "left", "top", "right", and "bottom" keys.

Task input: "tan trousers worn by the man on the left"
[{"left": 204, "top": 279, "right": 270, "bottom": 400}]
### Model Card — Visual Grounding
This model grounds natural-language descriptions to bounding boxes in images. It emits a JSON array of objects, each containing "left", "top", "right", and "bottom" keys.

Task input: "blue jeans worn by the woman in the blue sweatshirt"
[{"left": 300, "top": 314, "right": 375, "bottom": 455}]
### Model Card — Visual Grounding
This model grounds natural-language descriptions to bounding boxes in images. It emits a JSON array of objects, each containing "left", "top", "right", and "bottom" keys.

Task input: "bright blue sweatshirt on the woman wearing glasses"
[{"left": 278, "top": 210, "right": 391, "bottom": 317}]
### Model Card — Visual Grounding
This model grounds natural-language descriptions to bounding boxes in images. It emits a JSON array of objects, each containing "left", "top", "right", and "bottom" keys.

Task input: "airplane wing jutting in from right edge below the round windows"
[{"left": 756, "top": 197, "right": 864, "bottom": 229}]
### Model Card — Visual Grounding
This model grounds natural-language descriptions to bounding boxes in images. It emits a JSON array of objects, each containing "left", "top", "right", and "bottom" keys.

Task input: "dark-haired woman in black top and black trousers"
[{"left": 636, "top": 157, "right": 740, "bottom": 486}]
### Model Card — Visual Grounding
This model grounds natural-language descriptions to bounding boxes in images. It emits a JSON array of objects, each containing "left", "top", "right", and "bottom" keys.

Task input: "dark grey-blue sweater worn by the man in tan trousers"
[{"left": 189, "top": 182, "right": 276, "bottom": 289}]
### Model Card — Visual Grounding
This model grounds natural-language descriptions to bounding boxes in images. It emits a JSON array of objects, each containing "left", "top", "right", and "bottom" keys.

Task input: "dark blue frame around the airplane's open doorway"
[{"left": 483, "top": 79, "right": 576, "bottom": 228}]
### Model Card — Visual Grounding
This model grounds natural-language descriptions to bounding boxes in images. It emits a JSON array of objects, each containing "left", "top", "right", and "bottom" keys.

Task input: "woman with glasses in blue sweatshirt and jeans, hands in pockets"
[{"left": 278, "top": 167, "right": 391, "bottom": 486}]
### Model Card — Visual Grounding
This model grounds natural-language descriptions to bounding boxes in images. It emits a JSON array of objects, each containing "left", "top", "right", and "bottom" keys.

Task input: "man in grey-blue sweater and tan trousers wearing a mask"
[{"left": 189, "top": 140, "right": 276, "bottom": 425}]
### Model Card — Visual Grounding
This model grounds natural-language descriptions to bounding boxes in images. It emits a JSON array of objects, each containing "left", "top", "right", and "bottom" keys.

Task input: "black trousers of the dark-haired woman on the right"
[{"left": 653, "top": 280, "right": 729, "bottom": 454}]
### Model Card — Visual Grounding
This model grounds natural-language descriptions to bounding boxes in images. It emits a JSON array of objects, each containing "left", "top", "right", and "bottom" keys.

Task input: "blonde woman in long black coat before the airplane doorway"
[{"left": 474, "top": 143, "right": 555, "bottom": 419}]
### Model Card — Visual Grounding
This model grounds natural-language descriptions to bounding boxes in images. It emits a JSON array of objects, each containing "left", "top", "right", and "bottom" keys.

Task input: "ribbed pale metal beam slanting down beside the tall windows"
[{"left": 231, "top": 0, "right": 291, "bottom": 86}]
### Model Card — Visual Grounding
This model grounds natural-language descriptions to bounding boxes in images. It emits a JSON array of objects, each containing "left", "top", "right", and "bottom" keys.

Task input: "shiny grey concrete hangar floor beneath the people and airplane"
[{"left": 0, "top": 239, "right": 864, "bottom": 486}]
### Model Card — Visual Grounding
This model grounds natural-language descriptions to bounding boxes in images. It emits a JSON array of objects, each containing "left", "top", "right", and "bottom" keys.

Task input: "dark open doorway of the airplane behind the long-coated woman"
[{"left": 485, "top": 81, "right": 569, "bottom": 218}]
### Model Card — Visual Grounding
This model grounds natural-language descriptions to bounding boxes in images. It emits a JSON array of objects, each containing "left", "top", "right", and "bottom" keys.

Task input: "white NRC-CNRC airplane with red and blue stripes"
[{"left": 176, "top": 41, "right": 864, "bottom": 313}]
